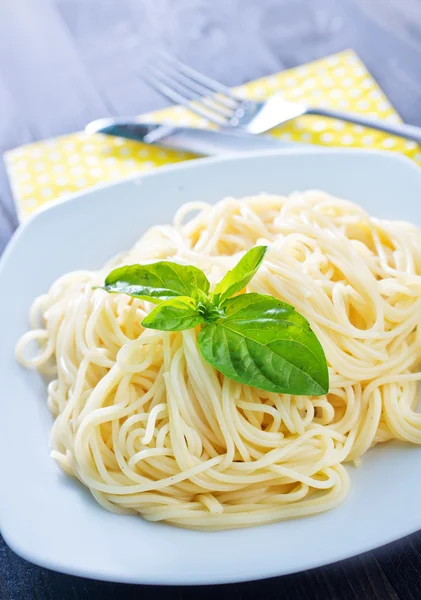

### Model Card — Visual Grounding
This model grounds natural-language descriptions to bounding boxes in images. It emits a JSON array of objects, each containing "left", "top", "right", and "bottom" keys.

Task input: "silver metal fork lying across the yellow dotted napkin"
[{"left": 143, "top": 53, "right": 421, "bottom": 143}]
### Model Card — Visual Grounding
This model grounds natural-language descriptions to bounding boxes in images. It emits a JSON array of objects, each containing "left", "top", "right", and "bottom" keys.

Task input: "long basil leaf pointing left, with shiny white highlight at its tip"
[{"left": 104, "top": 261, "right": 209, "bottom": 304}]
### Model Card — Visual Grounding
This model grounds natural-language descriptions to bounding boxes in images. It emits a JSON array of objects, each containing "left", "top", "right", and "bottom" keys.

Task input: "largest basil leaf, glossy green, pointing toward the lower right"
[{"left": 199, "top": 294, "right": 329, "bottom": 396}]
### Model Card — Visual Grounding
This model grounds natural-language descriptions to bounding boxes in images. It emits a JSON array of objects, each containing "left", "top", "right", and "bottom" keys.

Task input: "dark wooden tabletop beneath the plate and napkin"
[{"left": 0, "top": 0, "right": 421, "bottom": 600}]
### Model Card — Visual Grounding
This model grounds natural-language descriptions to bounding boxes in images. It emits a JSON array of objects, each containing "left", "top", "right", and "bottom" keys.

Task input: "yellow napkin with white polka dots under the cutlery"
[{"left": 5, "top": 50, "right": 421, "bottom": 219}]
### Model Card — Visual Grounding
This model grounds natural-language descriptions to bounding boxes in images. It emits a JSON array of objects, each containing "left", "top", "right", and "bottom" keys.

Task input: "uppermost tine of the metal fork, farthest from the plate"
[{"left": 157, "top": 52, "right": 241, "bottom": 110}]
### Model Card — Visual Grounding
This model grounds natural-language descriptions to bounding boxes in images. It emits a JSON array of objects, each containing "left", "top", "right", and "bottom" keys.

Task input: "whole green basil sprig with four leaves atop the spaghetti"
[{"left": 104, "top": 246, "right": 329, "bottom": 396}]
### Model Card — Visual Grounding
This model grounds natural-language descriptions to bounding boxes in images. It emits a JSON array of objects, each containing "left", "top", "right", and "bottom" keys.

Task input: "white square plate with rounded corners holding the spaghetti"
[{"left": 0, "top": 150, "right": 421, "bottom": 584}]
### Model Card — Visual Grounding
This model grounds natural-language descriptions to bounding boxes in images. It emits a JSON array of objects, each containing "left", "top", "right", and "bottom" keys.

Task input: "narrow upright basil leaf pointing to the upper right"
[{"left": 213, "top": 246, "right": 267, "bottom": 304}]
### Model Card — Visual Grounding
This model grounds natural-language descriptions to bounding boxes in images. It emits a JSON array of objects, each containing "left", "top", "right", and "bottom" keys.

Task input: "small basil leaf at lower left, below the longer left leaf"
[{"left": 142, "top": 296, "right": 204, "bottom": 331}]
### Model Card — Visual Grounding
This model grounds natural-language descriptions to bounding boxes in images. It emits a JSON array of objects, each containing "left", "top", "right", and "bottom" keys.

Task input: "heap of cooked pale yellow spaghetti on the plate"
[{"left": 17, "top": 191, "right": 421, "bottom": 530}]
